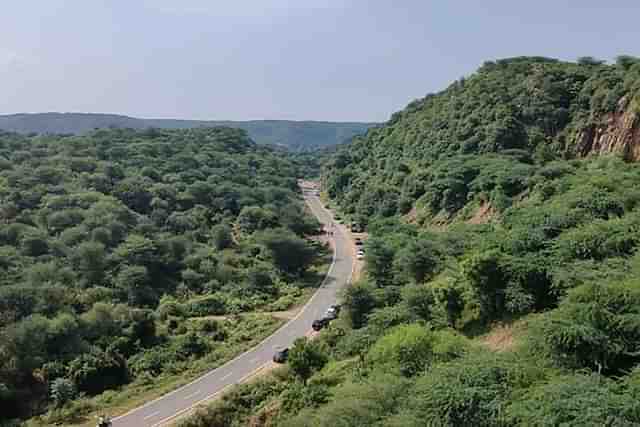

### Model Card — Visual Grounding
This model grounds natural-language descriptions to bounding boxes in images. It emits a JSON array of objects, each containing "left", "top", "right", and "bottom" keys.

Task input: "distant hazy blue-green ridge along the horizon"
[{"left": 0, "top": 113, "right": 376, "bottom": 150}]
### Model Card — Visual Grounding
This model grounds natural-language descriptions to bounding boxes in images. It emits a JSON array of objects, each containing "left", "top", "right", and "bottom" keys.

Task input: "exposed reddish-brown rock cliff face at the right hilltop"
[{"left": 575, "top": 97, "right": 640, "bottom": 161}]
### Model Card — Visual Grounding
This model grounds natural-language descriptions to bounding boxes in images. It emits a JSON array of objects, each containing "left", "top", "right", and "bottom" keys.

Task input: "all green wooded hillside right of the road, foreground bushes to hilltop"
[{"left": 178, "top": 57, "right": 640, "bottom": 427}]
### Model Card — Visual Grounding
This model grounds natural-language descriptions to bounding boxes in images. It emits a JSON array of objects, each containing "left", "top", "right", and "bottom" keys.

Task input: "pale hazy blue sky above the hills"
[{"left": 0, "top": 0, "right": 640, "bottom": 121}]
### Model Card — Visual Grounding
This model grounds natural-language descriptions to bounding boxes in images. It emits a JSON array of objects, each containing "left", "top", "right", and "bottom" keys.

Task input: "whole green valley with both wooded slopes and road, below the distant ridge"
[{"left": 0, "top": 56, "right": 640, "bottom": 427}]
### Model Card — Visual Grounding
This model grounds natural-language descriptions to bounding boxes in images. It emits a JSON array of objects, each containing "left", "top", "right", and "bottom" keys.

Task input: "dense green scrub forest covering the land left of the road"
[{"left": 0, "top": 128, "right": 322, "bottom": 425}]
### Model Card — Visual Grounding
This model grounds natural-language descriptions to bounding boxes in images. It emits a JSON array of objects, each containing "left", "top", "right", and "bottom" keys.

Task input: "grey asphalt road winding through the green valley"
[{"left": 113, "top": 195, "right": 354, "bottom": 427}]
